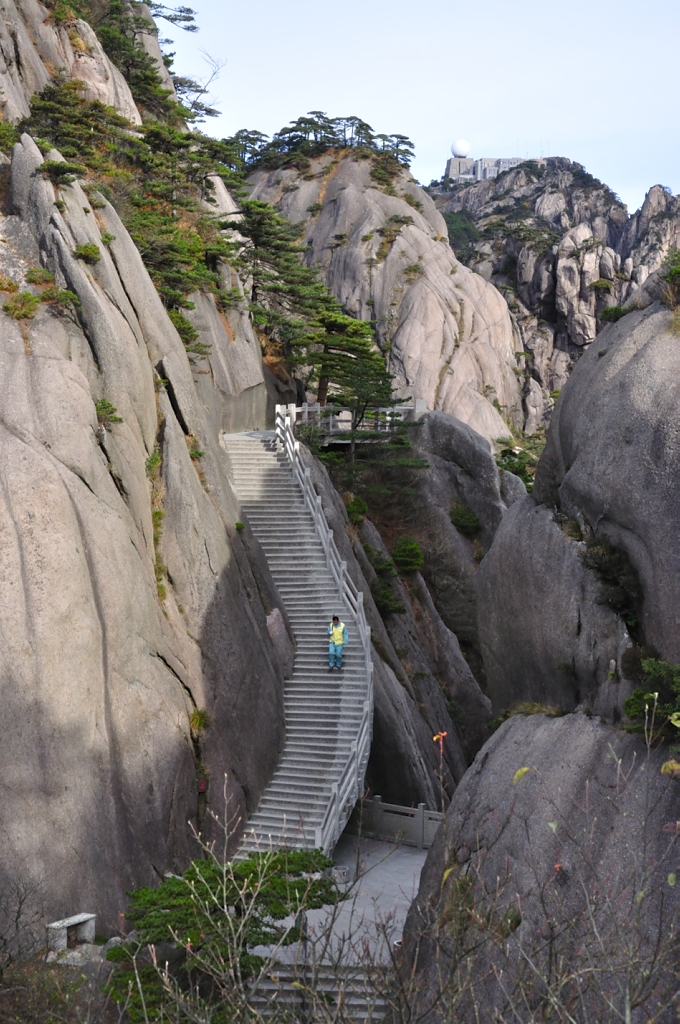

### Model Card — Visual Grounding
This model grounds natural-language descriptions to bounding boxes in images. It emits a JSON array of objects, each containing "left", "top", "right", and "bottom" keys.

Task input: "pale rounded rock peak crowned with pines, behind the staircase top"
[{"left": 249, "top": 153, "right": 522, "bottom": 440}]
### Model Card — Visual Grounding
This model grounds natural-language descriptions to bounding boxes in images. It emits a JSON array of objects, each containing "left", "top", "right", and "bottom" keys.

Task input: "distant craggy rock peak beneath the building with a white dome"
[{"left": 433, "top": 158, "right": 680, "bottom": 433}]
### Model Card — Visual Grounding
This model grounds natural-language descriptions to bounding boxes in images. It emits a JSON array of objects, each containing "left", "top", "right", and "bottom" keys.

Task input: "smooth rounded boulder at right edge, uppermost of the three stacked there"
[{"left": 535, "top": 304, "right": 680, "bottom": 662}]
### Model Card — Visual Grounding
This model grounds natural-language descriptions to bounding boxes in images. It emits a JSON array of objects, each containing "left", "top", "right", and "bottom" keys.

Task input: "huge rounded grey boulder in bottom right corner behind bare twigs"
[{"left": 402, "top": 714, "right": 680, "bottom": 1024}]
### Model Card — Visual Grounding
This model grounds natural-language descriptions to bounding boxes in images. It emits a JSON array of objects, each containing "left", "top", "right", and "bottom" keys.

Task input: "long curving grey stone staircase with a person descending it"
[{"left": 223, "top": 432, "right": 372, "bottom": 856}]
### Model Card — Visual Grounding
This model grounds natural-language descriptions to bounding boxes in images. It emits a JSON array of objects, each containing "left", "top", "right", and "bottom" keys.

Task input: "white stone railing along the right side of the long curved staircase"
[{"left": 275, "top": 406, "right": 373, "bottom": 853}]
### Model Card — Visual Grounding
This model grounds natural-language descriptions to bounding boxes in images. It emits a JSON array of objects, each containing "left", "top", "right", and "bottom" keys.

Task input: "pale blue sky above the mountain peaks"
[{"left": 165, "top": 0, "right": 680, "bottom": 212}]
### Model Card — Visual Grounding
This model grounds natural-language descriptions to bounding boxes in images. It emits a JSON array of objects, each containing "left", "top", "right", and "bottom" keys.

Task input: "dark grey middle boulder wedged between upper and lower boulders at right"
[{"left": 476, "top": 496, "right": 630, "bottom": 715}]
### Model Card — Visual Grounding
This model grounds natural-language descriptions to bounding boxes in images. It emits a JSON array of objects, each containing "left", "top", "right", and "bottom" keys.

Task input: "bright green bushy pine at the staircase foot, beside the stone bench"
[{"left": 106, "top": 847, "right": 341, "bottom": 1024}]
